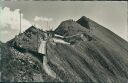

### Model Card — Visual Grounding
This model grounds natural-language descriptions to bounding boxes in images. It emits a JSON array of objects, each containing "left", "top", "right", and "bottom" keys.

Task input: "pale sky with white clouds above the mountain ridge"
[{"left": 0, "top": 1, "right": 128, "bottom": 42}]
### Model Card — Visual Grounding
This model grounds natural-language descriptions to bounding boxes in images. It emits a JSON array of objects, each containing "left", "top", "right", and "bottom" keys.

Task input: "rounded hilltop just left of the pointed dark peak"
[{"left": 55, "top": 20, "right": 89, "bottom": 36}]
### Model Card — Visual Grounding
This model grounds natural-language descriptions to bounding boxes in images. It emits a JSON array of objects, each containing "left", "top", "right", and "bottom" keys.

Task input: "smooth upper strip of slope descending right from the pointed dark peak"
[{"left": 77, "top": 18, "right": 128, "bottom": 52}]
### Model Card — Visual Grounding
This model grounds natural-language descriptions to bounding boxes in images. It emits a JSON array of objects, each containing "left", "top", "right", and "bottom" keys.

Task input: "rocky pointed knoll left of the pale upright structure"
[{"left": 7, "top": 26, "right": 45, "bottom": 51}]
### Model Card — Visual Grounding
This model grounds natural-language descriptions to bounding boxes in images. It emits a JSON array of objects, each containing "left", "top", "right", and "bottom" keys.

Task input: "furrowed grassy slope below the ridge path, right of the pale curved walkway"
[{"left": 47, "top": 39, "right": 128, "bottom": 83}]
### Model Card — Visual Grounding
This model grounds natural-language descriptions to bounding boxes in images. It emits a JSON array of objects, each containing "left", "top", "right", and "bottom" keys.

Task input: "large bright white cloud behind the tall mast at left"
[{"left": 0, "top": 7, "right": 31, "bottom": 42}]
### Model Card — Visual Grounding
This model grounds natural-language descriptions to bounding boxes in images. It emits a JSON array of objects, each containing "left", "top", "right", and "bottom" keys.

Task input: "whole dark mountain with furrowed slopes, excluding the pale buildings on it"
[{"left": 0, "top": 17, "right": 128, "bottom": 83}]
